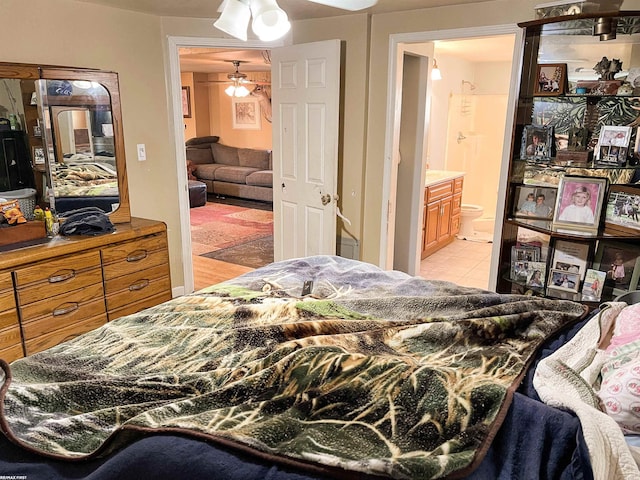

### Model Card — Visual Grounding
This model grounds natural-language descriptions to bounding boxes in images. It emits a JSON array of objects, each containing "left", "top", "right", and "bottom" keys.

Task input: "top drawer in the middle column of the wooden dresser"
[{"left": 15, "top": 250, "right": 100, "bottom": 289}]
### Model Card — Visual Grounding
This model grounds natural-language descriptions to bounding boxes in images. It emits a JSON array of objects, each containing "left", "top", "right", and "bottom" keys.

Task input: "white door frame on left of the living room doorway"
[{"left": 166, "top": 36, "right": 284, "bottom": 297}]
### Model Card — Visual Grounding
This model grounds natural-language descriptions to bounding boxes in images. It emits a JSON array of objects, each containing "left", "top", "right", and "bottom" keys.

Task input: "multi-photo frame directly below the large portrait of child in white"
[{"left": 547, "top": 240, "right": 590, "bottom": 293}]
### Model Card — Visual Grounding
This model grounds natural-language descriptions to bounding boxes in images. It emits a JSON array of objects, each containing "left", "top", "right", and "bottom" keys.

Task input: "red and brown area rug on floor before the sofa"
[{"left": 189, "top": 197, "right": 273, "bottom": 268}]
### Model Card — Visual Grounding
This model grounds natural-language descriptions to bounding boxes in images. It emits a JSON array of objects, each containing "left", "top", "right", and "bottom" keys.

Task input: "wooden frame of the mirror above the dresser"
[{"left": 0, "top": 62, "right": 131, "bottom": 223}]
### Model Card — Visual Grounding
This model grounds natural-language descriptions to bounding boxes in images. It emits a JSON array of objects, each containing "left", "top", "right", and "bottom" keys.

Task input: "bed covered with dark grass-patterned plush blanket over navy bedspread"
[{"left": 0, "top": 256, "right": 636, "bottom": 480}]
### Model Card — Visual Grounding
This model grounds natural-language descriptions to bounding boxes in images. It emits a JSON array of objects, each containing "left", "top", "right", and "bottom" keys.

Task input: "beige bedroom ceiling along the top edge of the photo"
[{"left": 76, "top": 0, "right": 491, "bottom": 20}]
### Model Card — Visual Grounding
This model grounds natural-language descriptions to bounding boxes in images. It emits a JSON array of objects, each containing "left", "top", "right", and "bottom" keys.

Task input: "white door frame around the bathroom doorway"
[{"left": 378, "top": 25, "right": 524, "bottom": 289}]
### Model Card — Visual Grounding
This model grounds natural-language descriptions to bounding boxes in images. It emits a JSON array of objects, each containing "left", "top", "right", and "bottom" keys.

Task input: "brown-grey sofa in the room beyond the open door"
[{"left": 186, "top": 136, "right": 273, "bottom": 202}]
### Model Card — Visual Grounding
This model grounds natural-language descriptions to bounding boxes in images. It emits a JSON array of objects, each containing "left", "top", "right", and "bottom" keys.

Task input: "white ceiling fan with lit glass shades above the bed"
[{"left": 213, "top": 0, "right": 378, "bottom": 42}]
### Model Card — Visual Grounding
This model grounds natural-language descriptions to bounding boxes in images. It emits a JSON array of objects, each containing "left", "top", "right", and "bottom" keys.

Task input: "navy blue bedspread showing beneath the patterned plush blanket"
[{"left": 0, "top": 310, "right": 593, "bottom": 480}]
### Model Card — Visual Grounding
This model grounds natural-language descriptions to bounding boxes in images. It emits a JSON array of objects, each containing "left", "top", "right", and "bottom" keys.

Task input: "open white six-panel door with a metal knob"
[{"left": 271, "top": 40, "right": 340, "bottom": 261}]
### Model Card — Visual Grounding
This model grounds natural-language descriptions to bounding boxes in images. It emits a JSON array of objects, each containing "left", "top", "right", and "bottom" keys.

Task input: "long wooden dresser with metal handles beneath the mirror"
[{"left": 0, "top": 218, "right": 171, "bottom": 362}]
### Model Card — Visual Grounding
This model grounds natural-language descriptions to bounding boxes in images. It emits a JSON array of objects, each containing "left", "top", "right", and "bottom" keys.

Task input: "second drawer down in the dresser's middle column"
[{"left": 20, "top": 284, "right": 106, "bottom": 328}]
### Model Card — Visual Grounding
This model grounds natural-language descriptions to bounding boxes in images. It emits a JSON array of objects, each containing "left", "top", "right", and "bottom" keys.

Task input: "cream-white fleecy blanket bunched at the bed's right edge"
[{"left": 533, "top": 302, "right": 640, "bottom": 480}]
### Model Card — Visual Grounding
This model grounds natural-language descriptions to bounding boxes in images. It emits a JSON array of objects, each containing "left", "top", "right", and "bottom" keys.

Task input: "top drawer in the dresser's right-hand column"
[{"left": 102, "top": 235, "right": 169, "bottom": 281}]
